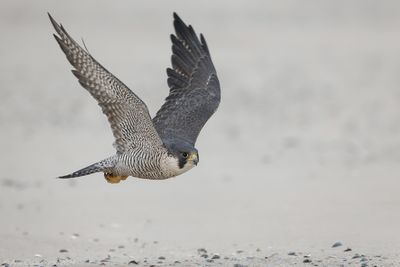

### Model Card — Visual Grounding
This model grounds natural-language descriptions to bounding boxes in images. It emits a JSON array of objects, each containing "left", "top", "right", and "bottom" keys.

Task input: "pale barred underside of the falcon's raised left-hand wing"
[{"left": 49, "top": 14, "right": 163, "bottom": 153}]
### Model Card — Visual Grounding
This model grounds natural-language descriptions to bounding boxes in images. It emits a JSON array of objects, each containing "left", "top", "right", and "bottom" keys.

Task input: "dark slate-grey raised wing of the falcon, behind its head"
[{"left": 153, "top": 13, "right": 221, "bottom": 145}]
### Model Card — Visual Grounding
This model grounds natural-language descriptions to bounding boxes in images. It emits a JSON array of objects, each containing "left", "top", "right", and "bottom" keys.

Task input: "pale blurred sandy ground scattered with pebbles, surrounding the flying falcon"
[{"left": 0, "top": 0, "right": 400, "bottom": 267}]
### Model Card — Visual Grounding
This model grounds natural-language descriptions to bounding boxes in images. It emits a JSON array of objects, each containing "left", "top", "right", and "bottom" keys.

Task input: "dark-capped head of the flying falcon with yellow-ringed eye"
[{"left": 166, "top": 142, "right": 199, "bottom": 173}]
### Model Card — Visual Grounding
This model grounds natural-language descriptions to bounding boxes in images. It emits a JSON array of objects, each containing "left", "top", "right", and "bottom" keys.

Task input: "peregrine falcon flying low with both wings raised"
[{"left": 48, "top": 13, "right": 221, "bottom": 183}]
